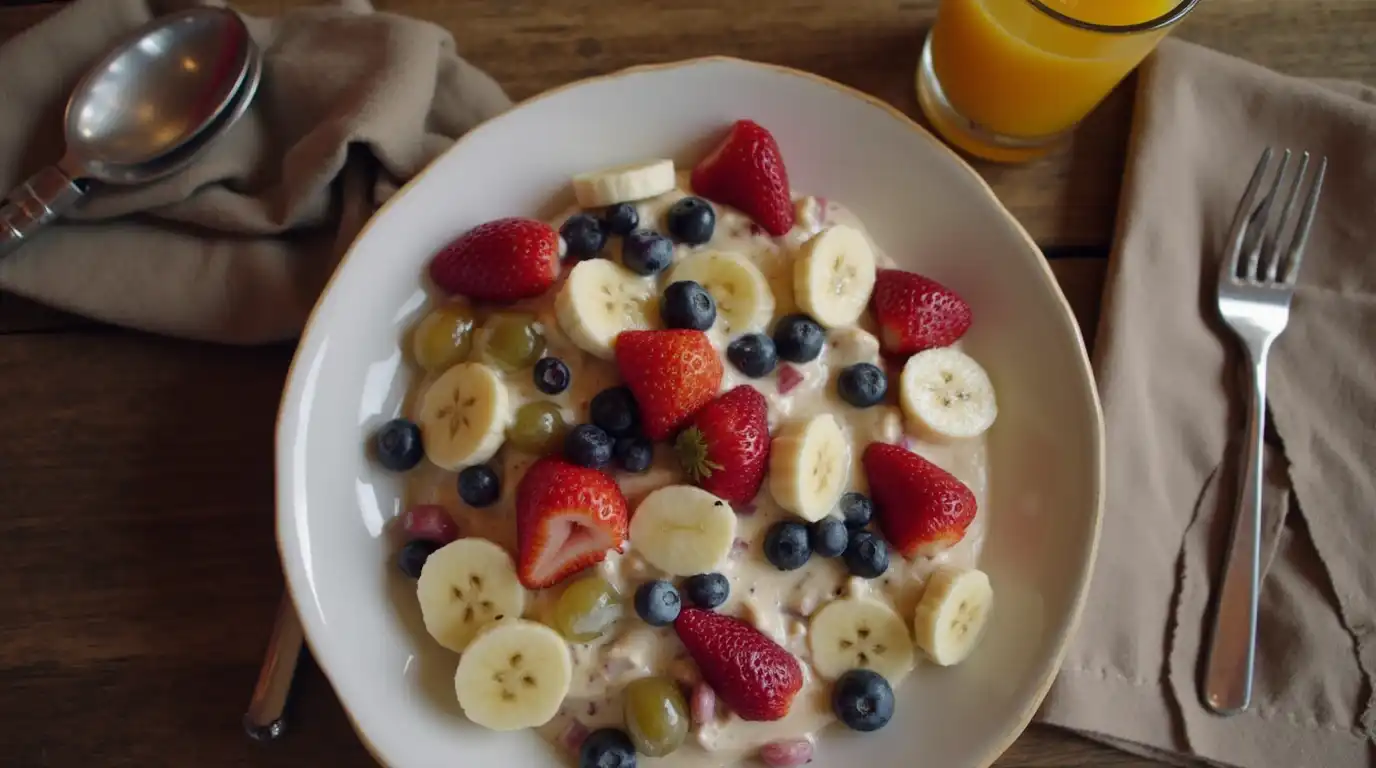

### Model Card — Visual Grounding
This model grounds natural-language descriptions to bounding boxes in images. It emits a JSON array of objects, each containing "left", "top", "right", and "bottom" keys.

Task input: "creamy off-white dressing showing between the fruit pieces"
[{"left": 406, "top": 178, "right": 988, "bottom": 768}]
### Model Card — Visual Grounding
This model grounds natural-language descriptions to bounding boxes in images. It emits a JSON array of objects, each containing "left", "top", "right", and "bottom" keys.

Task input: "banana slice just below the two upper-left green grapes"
[{"left": 418, "top": 363, "right": 512, "bottom": 471}]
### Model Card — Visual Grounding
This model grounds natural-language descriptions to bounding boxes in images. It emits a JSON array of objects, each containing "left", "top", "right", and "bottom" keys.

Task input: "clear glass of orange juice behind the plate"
[{"left": 918, "top": 0, "right": 1198, "bottom": 162}]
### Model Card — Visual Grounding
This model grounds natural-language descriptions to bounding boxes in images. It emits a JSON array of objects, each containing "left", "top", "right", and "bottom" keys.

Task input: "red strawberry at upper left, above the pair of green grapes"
[{"left": 429, "top": 219, "right": 559, "bottom": 301}]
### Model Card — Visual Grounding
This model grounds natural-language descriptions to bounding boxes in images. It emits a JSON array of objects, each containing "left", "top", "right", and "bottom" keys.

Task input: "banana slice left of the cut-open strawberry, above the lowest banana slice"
[{"left": 416, "top": 538, "right": 526, "bottom": 654}]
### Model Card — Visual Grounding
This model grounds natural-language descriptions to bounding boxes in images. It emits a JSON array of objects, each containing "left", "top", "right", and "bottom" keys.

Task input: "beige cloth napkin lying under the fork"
[{"left": 1039, "top": 41, "right": 1376, "bottom": 768}]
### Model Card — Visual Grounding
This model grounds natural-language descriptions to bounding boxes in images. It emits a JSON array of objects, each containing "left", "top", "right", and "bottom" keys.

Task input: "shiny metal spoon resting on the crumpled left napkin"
[{"left": 0, "top": 8, "right": 261, "bottom": 257}]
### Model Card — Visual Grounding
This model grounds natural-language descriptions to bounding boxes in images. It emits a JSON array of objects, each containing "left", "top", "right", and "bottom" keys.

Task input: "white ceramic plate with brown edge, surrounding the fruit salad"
[{"left": 277, "top": 58, "right": 1104, "bottom": 768}]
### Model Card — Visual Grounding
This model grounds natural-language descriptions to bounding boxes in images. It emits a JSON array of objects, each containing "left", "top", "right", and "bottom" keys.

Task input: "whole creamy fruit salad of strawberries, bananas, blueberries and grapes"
[{"left": 372, "top": 120, "right": 998, "bottom": 768}]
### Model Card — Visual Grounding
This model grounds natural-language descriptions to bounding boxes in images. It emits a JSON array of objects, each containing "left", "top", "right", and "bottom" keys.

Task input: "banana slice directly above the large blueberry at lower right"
[{"left": 808, "top": 597, "right": 914, "bottom": 685}]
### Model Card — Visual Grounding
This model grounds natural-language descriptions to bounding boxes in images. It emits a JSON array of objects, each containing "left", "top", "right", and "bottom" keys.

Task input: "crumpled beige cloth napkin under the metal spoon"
[{"left": 0, "top": 0, "right": 510, "bottom": 343}]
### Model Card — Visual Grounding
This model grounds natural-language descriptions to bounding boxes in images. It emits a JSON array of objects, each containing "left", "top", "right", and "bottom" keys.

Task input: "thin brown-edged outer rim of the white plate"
[{"left": 272, "top": 54, "right": 1106, "bottom": 768}]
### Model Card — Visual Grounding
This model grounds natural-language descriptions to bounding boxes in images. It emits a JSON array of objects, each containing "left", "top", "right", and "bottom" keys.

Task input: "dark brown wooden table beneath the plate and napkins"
[{"left": 0, "top": 0, "right": 1376, "bottom": 768}]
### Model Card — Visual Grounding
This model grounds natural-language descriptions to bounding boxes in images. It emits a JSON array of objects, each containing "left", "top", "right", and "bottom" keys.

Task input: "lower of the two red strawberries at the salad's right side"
[{"left": 860, "top": 443, "right": 976, "bottom": 557}]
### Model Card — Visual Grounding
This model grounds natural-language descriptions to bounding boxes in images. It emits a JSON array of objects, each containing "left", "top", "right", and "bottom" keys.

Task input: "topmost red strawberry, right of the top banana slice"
[{"left": 692, "top": 120, "right": 797, "bottom": 237}]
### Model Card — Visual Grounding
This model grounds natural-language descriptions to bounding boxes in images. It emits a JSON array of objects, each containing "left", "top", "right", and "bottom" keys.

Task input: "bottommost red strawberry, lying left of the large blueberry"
[{"left": 674, "top": 608, "right": 802, "bottom": 721}]
